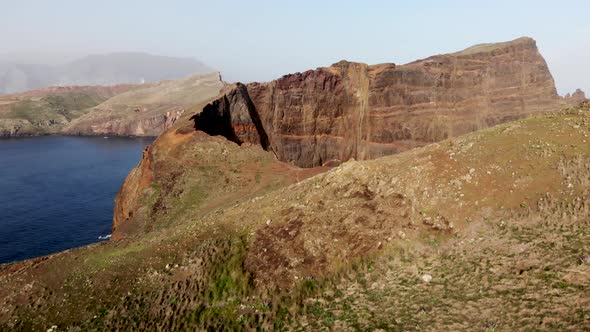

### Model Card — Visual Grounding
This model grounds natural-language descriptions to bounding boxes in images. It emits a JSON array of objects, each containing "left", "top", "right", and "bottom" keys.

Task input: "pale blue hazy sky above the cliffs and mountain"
[{"left": 0, "top": 0, "right": 590, "bottom": 94}]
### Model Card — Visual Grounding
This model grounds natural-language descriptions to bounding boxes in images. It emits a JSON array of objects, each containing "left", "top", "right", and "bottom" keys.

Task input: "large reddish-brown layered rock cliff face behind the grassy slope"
[{"left": 193, "top": 38, "right": 559, "bottom": 167}]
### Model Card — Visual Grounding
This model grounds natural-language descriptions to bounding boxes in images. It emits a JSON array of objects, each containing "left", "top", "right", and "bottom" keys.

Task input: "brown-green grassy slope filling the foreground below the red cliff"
[{"left": 0, "top": 103, "right": 590, "bottom": 331}]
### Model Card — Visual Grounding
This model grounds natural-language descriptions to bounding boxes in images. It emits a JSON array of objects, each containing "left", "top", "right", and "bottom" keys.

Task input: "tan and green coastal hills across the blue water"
[{"left": 0, "top": 72, "right": 223, "bottom": 137}]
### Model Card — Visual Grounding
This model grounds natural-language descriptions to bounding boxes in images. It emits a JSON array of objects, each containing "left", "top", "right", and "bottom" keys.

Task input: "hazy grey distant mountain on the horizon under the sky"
[{"left": 0, "top": 53, "right": 213, "bottom": 94}]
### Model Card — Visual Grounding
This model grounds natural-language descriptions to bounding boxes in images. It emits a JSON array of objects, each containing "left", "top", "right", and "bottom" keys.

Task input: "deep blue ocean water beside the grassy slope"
[{"left": 0, "top": 136, "right": 152, "bottom": 263}]
